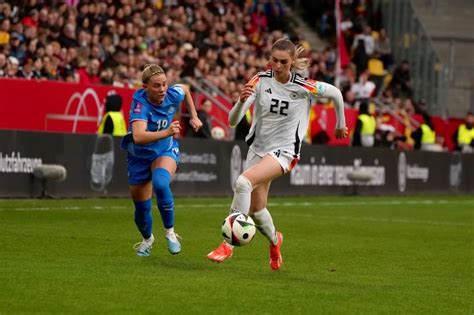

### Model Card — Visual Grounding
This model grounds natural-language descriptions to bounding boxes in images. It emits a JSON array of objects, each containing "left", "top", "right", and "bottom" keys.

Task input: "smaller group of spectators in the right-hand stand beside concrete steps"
[{"left": 288, "top": 0, "right": 474, "bottom": 151}]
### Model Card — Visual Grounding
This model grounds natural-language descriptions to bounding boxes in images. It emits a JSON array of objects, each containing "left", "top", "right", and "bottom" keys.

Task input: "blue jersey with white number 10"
[{"left": 121, "top": 85, "right": 184, "bottom": 159}]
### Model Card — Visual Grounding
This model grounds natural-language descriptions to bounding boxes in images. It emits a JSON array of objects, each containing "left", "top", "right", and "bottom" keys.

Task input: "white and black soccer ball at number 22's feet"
[{"left": 222, "top": 213, "right": 256, "bottom": 246}]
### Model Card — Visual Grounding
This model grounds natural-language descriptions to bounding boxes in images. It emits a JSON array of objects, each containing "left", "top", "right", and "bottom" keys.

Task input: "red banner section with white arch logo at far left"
[{"left": 0, "top": 79, "right": 134, "bottom": 133}]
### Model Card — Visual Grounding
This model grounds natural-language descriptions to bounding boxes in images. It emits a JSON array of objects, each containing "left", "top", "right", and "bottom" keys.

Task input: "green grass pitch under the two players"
[{"left": 0, "top": 196, "right": 474, "bottom": 314}]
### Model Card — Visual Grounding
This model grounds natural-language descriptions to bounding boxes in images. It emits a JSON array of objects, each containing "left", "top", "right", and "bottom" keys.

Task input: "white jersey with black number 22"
[{"left": 244, "top": 70, "right": 326, "bottom": 159}]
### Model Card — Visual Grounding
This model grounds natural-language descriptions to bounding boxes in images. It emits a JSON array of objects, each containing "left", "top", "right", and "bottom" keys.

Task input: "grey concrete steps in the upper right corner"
[{"left": 412, "top": 0, "right": 474, "bottom": 117}]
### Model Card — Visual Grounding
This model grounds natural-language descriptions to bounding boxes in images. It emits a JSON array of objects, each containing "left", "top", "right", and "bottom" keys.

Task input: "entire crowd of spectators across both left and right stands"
[{"left": 0, "top": 0, "right": 472, "bottom": 149}]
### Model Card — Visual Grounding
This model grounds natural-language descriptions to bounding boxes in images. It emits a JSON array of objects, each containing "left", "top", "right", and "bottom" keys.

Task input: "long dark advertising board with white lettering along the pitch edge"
[{"left": 0, "top": 131, "right": 474, "bottom": 198}]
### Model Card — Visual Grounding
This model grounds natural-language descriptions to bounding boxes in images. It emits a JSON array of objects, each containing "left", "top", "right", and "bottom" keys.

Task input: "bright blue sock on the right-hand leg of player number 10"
[{"left": 153, "top": 168, "right": 174, "bottom": 229}]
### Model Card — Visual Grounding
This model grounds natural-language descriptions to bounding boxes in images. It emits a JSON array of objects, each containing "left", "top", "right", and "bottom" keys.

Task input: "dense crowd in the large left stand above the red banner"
[{"left": 0, "top": 0, "right": 286, "bottom": 100}]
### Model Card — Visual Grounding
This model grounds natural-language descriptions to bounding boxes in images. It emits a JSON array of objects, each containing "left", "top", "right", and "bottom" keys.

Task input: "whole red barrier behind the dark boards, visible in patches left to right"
[{"left": 0, "top": 79, "right": 462, "bottom": 149}]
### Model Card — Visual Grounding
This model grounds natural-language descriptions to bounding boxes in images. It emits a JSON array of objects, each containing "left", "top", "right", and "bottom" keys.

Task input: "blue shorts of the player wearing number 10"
[{"left": 127, "top": 141, "right": 179, "bottom": 185}]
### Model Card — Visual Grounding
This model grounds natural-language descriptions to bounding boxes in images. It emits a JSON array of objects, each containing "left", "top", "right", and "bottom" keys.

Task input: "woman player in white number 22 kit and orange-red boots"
[{"left": 207, "top": 38, "right": 348, "bottom": 270}]
